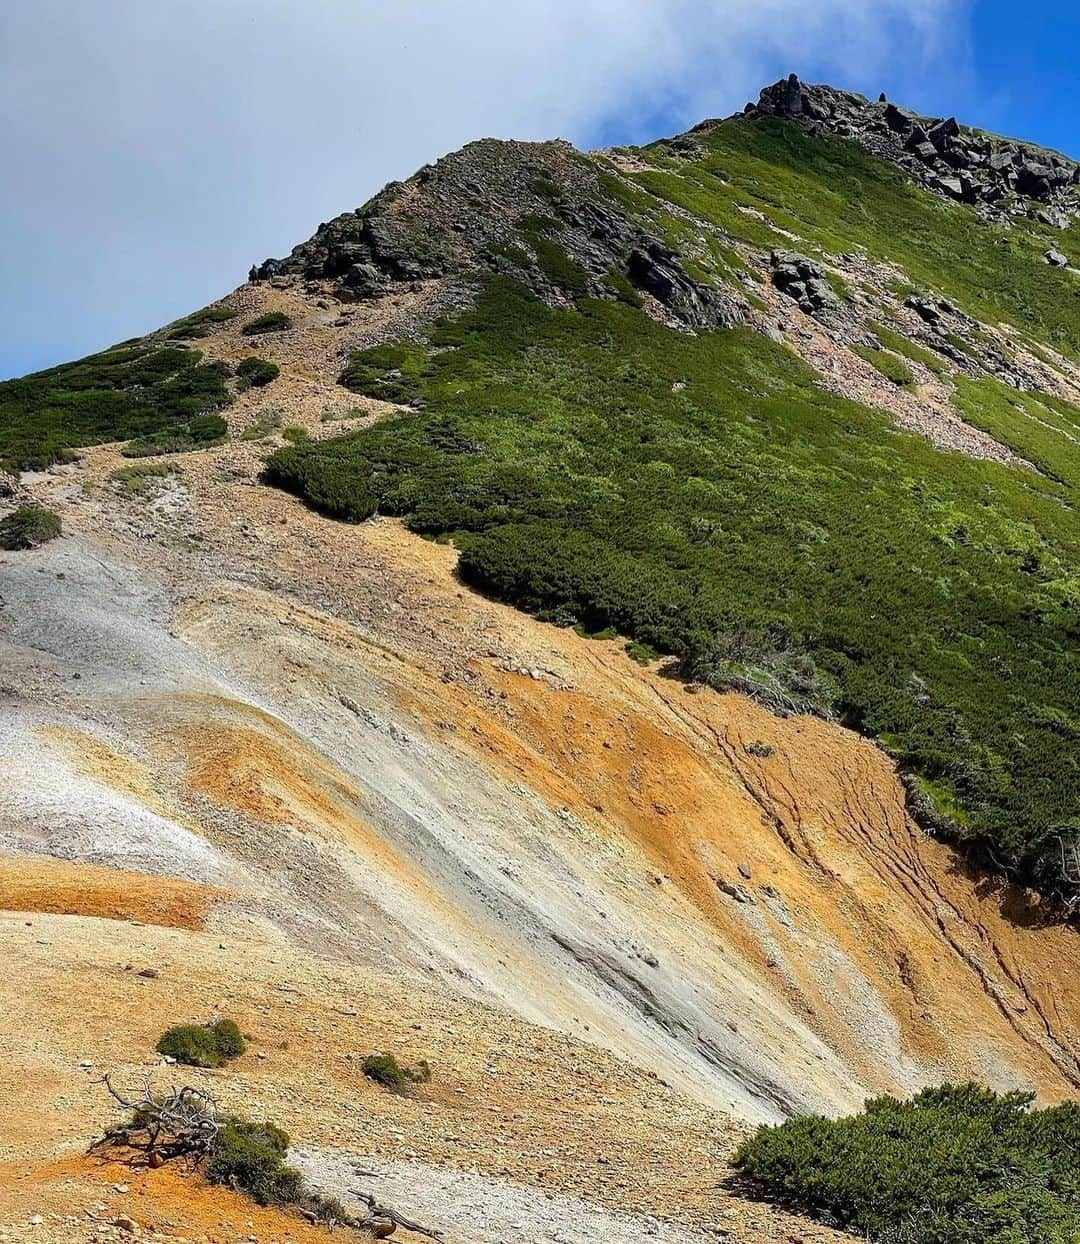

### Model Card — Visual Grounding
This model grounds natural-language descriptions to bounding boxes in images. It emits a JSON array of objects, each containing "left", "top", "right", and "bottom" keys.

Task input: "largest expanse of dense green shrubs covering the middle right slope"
[{"left": 268, "top": 279, "right": 1080, "bottom": 905}]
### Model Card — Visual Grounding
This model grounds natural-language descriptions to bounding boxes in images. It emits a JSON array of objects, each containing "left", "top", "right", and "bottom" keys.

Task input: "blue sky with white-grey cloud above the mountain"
[{"left": 0, "top": 0, "right": 1080, "bottom": 377}]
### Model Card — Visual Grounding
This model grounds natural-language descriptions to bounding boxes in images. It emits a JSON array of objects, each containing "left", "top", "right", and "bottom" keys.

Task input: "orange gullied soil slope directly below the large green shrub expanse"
[{"left": 379, "top": 525, "right": 1080, "bottom": 1100}]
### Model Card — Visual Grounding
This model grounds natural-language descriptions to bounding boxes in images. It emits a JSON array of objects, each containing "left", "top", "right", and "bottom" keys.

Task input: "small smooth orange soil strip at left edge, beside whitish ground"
[{"left": 0, "top": 856, "right": 220, "bottom": 929}]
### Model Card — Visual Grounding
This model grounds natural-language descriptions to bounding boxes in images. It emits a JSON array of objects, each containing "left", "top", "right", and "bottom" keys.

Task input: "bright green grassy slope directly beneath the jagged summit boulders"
[{"left": 630, "top": 118, "right": 1080, "bottom": 357}]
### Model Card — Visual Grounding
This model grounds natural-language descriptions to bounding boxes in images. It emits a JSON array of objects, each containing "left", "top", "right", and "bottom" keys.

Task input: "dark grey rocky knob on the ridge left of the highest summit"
[{"left": 250, "top": 139, "right": 745, "bottom": 327}]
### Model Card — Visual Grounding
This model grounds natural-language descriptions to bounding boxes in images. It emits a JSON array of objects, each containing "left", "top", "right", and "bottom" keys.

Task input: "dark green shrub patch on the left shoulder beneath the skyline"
[{"left": 0, "top": 342, "right": 230, "bottom": 470}]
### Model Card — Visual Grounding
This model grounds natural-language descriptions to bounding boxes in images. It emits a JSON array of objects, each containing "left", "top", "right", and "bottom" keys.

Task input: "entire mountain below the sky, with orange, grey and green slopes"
[{"left": 0, "top": 78, "right": 1080, "bottom": 1244}]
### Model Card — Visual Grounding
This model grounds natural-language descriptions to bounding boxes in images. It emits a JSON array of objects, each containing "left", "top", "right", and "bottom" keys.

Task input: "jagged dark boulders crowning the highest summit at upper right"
[{"left": 744, "top": 73, "right": 1080, "bottom": 228}]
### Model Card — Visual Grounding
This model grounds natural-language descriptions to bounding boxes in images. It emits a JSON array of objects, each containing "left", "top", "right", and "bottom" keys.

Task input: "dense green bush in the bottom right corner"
[{"left": 735, "top": 1085, "right": 1080, "bottom": 1244}]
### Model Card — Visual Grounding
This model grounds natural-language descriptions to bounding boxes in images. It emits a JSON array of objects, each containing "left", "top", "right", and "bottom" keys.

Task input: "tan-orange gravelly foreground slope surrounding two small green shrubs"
[{"left": 0, "top": 917, "right": 766, "bottom": 1239}]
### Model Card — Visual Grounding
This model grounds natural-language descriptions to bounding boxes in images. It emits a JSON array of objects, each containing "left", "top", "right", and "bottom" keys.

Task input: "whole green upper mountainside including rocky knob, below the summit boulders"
[{"left": 263, "top": 88, "right": 1080, "bottom": 907}]
